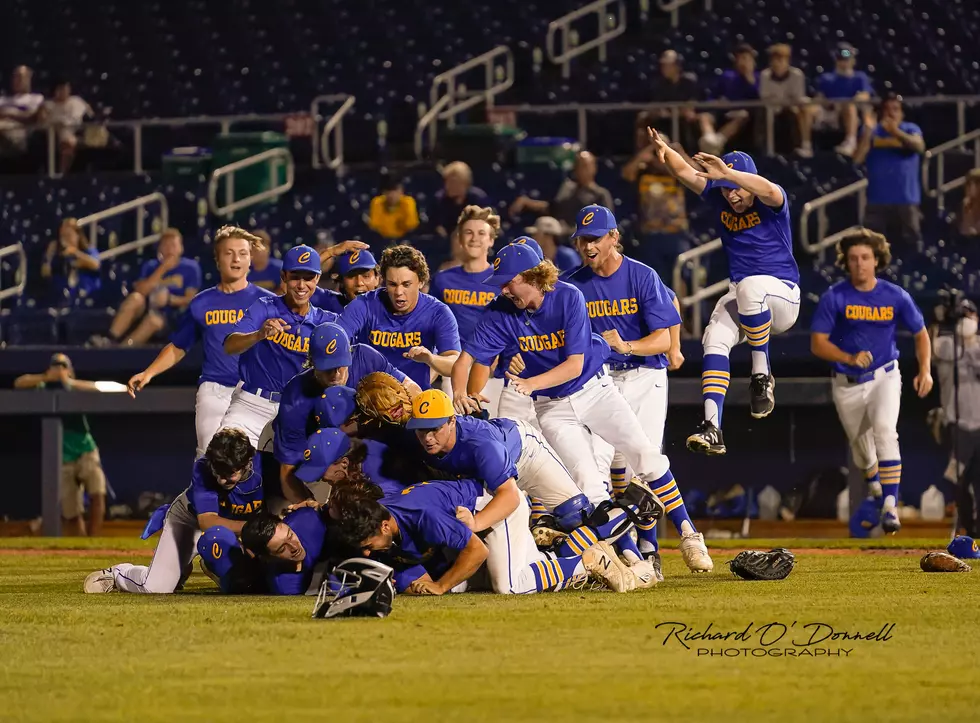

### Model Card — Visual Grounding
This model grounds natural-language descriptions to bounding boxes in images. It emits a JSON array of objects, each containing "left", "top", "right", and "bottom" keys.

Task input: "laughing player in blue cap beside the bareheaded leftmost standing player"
[{"left": 221, "top": 246, "right": 339, "bottom": 449}]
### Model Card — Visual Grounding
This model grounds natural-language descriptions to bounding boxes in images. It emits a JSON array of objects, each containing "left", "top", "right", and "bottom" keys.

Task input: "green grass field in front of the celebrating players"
[{"left": 0, "top": 538, "right": 980, "bottom": 723}]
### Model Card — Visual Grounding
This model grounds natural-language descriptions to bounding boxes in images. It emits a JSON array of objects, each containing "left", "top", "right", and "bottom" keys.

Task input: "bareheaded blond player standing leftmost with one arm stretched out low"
[{"left": 126, "top": 226, "right": 274, "bottom": 457}]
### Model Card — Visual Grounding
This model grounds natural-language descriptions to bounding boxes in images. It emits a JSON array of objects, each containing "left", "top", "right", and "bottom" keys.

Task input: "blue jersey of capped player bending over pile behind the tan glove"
[{"left": 272, "top": 344, "right": 405, "bottom": 464}]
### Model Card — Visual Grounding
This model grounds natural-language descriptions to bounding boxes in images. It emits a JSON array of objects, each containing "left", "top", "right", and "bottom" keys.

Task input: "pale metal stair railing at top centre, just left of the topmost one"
[{"left": 415, "top": 45, "right": 514, "bottom": 158}]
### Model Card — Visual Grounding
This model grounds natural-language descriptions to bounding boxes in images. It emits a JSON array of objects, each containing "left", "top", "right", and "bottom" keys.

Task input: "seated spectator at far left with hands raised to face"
[{"left": 41, "top": 218, "right": 102, "bottom": 305}]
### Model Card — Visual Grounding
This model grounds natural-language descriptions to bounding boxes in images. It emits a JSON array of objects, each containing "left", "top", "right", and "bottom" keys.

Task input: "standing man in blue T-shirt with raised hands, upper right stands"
[{"left": 854, "top": 93, "right": 926, "bottom": 248}]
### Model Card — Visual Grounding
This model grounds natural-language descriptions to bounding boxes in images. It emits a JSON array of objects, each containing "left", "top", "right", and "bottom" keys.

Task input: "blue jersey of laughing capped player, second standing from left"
[{"left": 229, "top": 296, "right": 338, "bottom": 392}]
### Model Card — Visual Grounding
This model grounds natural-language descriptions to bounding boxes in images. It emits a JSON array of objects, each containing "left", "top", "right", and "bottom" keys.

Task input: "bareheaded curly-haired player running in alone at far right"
[{"left": 810, "top": 229, "right": 932, "bottom": 533}]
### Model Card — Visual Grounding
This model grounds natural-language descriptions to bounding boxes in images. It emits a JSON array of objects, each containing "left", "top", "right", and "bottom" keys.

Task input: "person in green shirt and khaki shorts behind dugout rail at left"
[{"left": 14, "top": 353, "right": 106, "bottom": 537}]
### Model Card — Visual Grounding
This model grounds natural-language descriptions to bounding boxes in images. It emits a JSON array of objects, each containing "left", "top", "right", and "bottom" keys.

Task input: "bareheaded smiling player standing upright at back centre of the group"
[{"left": 429, "top": 206, "right": 503, "bottom": 417}]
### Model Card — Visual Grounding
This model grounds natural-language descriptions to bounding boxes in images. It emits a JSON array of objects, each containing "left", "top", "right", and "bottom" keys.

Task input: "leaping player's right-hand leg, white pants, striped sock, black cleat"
[{"left": 735, "top": 276, "right": 800, "bottom": 419}]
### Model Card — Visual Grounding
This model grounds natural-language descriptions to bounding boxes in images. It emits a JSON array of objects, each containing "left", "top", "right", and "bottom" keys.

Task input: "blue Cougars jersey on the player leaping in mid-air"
[{"left": 701, "top": 181, "right": 800, "bottom": 284}]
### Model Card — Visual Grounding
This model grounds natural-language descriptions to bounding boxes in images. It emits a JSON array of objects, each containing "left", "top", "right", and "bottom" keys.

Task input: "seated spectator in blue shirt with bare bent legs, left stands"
[{"left": 91, "top": 228, "right": 201, "bottom": 346}]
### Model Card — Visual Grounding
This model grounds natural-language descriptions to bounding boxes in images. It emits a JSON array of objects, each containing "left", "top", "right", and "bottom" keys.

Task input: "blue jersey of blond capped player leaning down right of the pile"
[{"left": 465, "top": 281, "right": 609, "bottom": 397}]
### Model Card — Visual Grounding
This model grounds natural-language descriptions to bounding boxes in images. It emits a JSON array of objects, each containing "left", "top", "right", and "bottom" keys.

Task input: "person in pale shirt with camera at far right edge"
[{"left": 931, "top": 293, "right": 980, "bottom": 537}]
